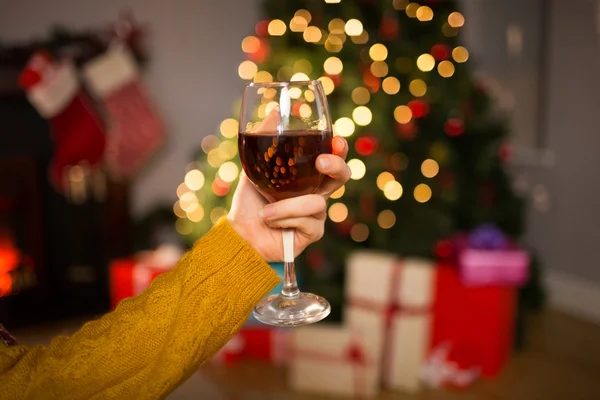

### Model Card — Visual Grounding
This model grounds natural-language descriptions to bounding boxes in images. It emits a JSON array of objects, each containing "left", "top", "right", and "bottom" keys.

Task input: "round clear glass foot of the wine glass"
[{"left": 253, "top": 293, "right": 331, "bottom": 327}]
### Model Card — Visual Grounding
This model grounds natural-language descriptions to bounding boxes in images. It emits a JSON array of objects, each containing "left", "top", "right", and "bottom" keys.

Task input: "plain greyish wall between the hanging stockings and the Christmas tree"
[{"left": 0, "top": 0, "right": 258, "bottom": 215}]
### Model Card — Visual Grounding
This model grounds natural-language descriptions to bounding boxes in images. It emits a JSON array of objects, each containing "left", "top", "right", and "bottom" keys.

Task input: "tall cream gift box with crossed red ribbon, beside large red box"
[{"left": 345, "top": 251, "right": 435, "bottom": 392}]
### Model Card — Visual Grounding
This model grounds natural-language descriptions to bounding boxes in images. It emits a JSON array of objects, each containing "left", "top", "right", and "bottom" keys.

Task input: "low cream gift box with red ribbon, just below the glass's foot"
[{"left": 288, "top": 325, "right": 379, "bottom": 398}]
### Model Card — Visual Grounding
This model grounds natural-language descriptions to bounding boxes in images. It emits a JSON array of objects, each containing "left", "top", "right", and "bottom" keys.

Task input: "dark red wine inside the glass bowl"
[{"left": 238, "top": 131, "right": 333, "bottom": 201}]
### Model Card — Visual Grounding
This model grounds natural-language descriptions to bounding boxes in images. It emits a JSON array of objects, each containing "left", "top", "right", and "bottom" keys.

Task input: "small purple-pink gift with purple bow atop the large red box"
[{"left": 455, "top": 225, "right": 530, "bottom": 286}]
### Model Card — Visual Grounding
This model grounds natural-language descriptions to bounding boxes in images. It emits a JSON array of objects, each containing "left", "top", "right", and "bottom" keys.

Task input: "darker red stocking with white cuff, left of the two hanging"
[{"left": 19, "top": 52, "right": 105, "bottom": 192}]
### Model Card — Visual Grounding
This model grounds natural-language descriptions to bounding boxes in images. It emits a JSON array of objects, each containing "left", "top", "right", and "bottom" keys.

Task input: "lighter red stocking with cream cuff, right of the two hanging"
[{"left": 84, "top": 48, "right": 164, "bottom": 179}]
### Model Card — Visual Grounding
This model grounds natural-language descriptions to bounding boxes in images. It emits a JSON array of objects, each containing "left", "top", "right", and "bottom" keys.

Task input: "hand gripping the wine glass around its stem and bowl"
[{"left": 227, "top": 136, "right": 350, "bottom": 262}]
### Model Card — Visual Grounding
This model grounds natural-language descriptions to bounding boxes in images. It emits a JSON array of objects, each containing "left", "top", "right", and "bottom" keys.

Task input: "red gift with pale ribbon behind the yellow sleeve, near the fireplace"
[{"left": 109, "top": 246, "right": 183, "bottom": 309}]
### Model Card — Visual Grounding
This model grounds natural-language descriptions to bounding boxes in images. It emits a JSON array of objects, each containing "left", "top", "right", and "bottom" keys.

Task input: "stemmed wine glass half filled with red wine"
[{"left": 238, "top": 81, "right": 333, "bottom": 326}]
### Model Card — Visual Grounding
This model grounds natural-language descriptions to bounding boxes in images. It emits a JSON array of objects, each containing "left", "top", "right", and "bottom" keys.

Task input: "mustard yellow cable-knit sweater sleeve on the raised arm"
[{"left": 0, "top": 221, "right": 279, "bottom": 400}]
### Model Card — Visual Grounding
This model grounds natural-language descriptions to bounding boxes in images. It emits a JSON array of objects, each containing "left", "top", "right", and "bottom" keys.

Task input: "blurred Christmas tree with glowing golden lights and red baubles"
[{"left": 174, "top": 0, "right": 540, "bottom": 318}]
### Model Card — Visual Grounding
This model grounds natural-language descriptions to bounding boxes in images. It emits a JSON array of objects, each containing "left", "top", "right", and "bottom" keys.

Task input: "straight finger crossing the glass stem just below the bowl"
[{"left": 260, "top": 194, "right": 327, "bottom": 222}]
